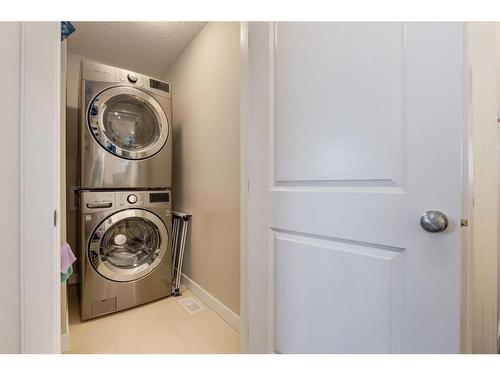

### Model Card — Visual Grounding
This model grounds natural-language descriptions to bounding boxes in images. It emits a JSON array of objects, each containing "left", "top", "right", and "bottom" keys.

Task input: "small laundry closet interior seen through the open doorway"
[{"left": 60, "top": 22, "right": 241, "bottom": 354}]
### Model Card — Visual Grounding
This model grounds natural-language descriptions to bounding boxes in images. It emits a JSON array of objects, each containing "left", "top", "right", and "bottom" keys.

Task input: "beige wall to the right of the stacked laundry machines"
[{"left": 164, "top": 22, "right": 240, "bottom": 314}]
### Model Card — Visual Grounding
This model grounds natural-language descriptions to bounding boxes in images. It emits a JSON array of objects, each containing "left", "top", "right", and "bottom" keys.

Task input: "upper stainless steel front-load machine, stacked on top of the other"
[{"left": 80, "top": 60, "right": 172, "bottom": 189}]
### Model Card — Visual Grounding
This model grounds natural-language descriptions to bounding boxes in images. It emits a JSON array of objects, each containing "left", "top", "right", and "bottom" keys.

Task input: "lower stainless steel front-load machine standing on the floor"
[{"left": 79, "top": 190, "right": 172, "bottom": 320}]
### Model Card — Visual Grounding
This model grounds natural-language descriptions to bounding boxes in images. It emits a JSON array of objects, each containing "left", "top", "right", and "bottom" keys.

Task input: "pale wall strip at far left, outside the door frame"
[{"left": 0, "top": 22, "right": 21, "bottom": 353}]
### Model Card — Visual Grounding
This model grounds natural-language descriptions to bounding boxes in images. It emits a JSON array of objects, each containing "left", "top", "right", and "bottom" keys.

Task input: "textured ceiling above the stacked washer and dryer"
[{"left": 68, "top": 22, "right": 206, "bottom": 78}]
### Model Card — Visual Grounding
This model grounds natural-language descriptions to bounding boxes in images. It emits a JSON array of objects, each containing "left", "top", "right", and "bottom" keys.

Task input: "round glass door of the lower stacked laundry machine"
[{"left": 89, "top": 209, "right": 169, "bottom": 281}]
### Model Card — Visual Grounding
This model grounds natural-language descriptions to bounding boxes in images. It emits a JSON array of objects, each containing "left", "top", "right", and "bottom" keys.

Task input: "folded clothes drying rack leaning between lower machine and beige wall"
[{"left": 172, "top": 211, "right": 192, "bottom": 297}]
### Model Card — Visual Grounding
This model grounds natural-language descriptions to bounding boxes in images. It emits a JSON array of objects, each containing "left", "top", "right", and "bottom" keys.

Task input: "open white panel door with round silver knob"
[{"left": 248, "top": 23, "right": 464, "bottom": 353}]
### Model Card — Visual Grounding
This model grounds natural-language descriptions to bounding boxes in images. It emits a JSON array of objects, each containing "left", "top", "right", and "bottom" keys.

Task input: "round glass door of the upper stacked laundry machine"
[{"left": 88, "top": 86, "right": 169, "bottom": 160}]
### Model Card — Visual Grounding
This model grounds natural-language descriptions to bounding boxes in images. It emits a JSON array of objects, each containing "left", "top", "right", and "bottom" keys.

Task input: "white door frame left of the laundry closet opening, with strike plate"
[{"left": 20, "top": 22, "right": 61, "bottom": 353}]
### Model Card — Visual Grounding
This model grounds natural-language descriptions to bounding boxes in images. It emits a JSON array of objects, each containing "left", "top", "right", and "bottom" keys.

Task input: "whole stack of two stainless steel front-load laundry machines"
[{"left": 80, "top": 61, "right": 172, "bottom": 320}]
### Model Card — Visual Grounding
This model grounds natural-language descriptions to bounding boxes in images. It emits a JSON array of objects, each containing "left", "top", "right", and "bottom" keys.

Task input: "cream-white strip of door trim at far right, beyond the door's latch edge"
[{"left": 461, "top": 22, "right": 499, "bottom": 353}]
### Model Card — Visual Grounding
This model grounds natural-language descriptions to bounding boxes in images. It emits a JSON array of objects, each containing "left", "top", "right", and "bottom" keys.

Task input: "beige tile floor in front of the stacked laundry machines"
[{"left": 66, "top": 286, "right": 239, "bottom": 354}]
